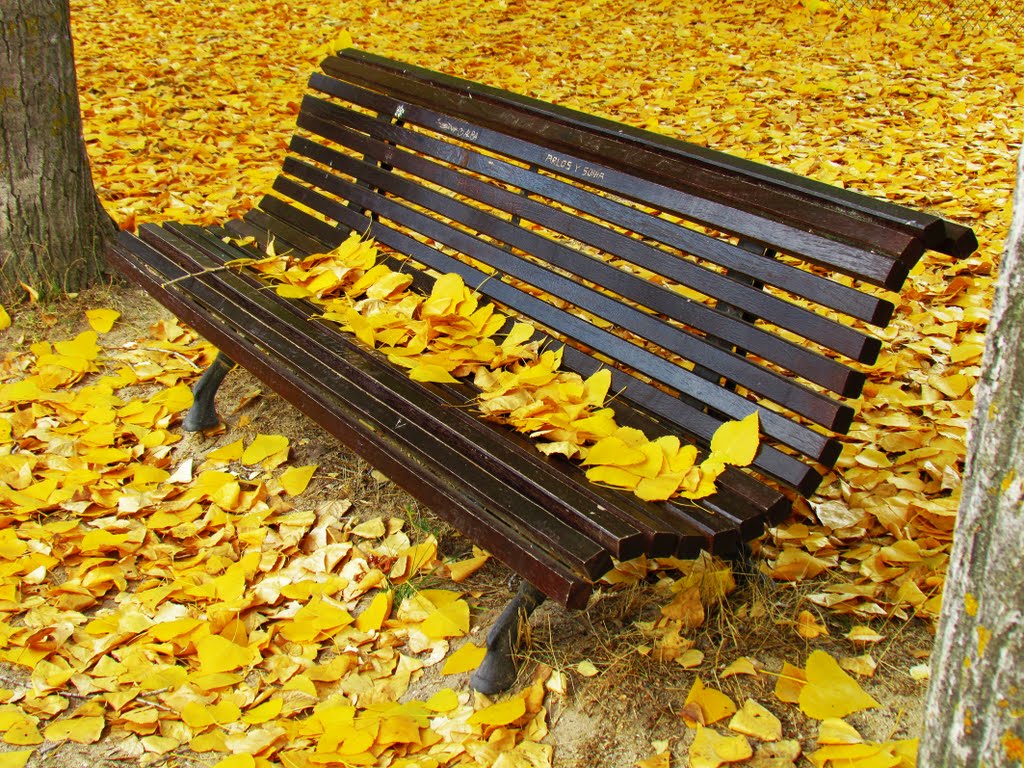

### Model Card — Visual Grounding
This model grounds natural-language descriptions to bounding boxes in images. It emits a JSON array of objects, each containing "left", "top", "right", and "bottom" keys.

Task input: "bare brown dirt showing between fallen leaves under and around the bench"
[{"left": 0, "top": 286, "right": 932, "bottom": 768}]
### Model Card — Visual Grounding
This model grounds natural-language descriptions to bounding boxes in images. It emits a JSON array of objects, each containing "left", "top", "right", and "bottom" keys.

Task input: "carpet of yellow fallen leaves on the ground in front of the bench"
[{"left": 0, "top": 310, "right": 569, "bottom": 768}]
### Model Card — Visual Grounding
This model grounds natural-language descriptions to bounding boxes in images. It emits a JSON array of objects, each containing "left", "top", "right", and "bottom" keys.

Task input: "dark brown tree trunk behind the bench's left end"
[{"left": 0, "top": 0, "right": 115, "bottom": 300}]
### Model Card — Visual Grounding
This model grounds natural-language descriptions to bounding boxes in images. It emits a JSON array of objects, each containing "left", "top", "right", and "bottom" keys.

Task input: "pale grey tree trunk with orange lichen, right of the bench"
[{"left": 920, "top": 152, "right": 1024, "bottom": 768}]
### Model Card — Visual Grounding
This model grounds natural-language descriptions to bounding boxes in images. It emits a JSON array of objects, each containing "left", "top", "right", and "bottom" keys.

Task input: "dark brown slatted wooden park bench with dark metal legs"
[{"left": 103, "top": 49, "right": 977, "bottom": 690}]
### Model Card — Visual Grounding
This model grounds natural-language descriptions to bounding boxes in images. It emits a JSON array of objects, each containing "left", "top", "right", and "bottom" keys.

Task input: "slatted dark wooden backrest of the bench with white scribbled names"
[{"left": 243, "top": 50, "right": 976, "bottom": 494}]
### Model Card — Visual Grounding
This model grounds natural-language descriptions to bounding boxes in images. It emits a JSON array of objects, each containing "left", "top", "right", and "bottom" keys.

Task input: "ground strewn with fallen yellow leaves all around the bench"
[{"left": 0, "top": 0, "right": 1024, "bottom": 768}]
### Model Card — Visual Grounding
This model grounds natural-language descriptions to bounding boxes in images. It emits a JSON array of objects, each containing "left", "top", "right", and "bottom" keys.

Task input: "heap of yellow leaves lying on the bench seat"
[{"left": 235, "top": 232, "right": 759, "bottom": 501}]
